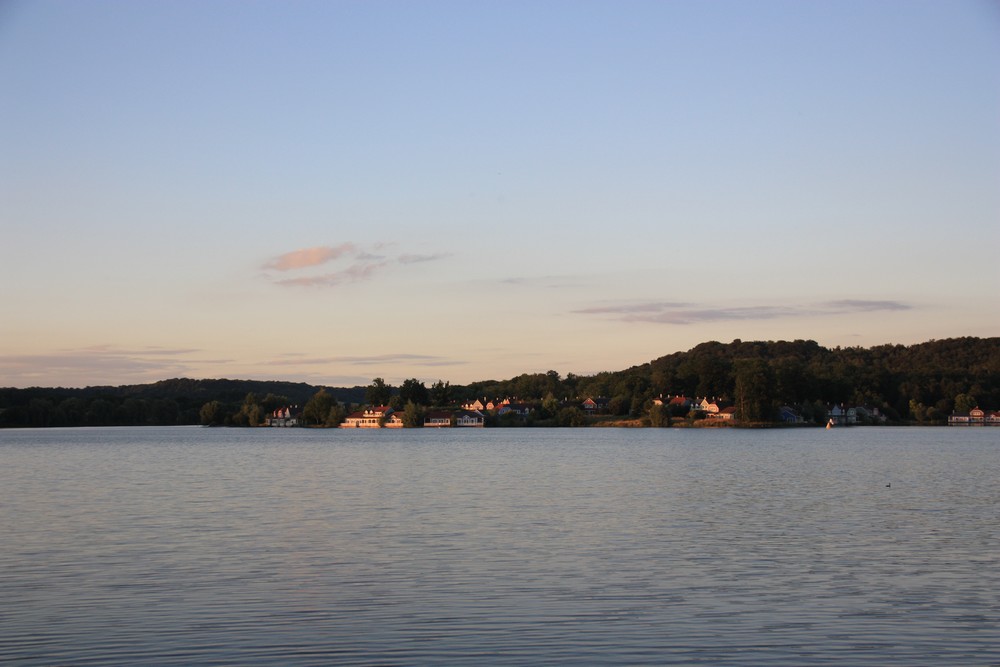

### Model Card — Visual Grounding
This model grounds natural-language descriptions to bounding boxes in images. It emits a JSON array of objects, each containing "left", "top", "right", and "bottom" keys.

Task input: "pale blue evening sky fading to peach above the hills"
[{"left": 0, "top": 0, "right": 1000, "bottom": 387}]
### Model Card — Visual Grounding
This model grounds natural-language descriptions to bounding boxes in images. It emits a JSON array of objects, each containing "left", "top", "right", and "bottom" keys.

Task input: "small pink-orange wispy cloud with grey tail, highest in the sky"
[{"left": 263, "top": 242, "right": 451, "bottom": 287}]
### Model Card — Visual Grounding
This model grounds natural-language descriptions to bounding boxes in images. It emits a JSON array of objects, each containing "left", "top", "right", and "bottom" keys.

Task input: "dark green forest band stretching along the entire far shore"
[{"left": 0, "top": 338, "right": 1000, "bottom": 427}]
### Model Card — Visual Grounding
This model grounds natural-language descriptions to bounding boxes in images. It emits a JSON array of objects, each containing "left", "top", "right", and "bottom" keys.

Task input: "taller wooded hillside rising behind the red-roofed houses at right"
[{"left": 467, "top": 338, "right": 1000, "bottom": 422}]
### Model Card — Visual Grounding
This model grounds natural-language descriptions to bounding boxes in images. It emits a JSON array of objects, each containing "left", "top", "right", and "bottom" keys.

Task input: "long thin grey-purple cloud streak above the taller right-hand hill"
[{"left": 573, "top": 299, "right": 912, "bottom": 325}]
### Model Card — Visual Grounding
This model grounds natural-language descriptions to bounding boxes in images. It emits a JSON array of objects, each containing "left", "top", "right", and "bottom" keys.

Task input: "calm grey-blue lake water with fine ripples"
[{"left": 0, "top": 427, "right": 1000, "bottom": 665}]
